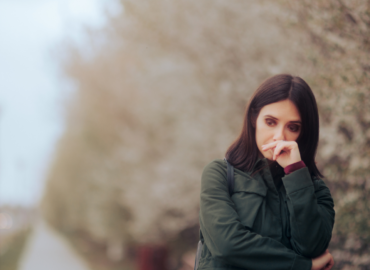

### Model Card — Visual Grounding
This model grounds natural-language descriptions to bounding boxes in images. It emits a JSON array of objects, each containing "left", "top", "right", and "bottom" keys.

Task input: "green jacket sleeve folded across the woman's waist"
[{"left": 199, "top": 161, "right": 312, "bottom": 270}]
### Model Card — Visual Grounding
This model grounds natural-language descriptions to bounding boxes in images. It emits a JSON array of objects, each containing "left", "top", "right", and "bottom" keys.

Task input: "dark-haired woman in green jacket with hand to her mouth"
[{"left": 198, "top": 74, "right": 335, "bottom": 270}]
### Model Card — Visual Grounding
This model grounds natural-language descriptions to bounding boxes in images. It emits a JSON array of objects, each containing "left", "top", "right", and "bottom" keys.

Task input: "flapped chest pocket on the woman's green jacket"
[{"left": 231, "top": 177, "right": 267, "bottom": 230}]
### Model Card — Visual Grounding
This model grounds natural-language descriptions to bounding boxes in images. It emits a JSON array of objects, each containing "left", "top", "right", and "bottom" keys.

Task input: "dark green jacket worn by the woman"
[{"left": 198, "top": 158, "right": 335, "bottom": 270}]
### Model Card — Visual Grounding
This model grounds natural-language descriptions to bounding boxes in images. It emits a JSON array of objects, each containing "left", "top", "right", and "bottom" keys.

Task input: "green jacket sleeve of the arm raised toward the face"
[{"left": 282, "top": 167, "right": 335, "bottom": 258}]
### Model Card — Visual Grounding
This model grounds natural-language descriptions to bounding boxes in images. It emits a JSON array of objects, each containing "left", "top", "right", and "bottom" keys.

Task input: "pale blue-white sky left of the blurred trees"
[{"left": 0, "top": 0, "right": 120, "bottom": 205}]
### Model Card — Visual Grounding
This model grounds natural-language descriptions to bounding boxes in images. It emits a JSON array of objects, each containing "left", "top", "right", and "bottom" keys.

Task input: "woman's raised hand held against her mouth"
[{"left": 262, "top": 140, "right": 301, "bottom": 168}]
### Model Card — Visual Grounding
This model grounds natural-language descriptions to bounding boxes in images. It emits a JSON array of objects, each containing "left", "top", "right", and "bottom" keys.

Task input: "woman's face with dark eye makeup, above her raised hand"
[{"left": 256, "top": 99, "right": 302, "bottom": 160}]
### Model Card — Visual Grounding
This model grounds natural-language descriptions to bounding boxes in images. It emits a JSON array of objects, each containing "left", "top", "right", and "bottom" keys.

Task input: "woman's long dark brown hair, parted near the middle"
[{"left": 225, "top": 74, "right": 324, "bottom": 177}]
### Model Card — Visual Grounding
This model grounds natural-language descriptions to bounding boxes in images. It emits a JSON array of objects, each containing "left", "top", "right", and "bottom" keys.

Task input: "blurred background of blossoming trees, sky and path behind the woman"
[{"left": 0, "top": 0, "right": 370, "bottom": 270}]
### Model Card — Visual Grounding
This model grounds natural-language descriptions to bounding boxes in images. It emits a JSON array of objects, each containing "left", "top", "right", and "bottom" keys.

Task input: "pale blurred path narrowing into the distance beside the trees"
[{"left": 19, "top": 221, "right": 89, "bottom": 270}]
